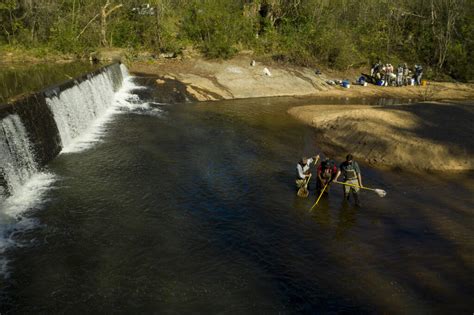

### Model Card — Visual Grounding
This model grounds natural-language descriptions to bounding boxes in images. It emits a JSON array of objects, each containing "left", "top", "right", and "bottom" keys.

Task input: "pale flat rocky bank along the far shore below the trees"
[{"left": 129, "top": 54, "right": 474, "bottom": 101}]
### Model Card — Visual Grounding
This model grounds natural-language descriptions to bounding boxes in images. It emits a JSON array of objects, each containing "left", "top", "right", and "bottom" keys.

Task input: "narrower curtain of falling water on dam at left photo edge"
[{"left": 0, "top": 114, "right": 38, "bottom": 200}]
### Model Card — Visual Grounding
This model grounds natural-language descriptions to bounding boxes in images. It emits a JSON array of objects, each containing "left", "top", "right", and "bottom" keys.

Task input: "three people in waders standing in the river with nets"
[{"left": 296, "top": 154, "right": 363, "bottom": 206}]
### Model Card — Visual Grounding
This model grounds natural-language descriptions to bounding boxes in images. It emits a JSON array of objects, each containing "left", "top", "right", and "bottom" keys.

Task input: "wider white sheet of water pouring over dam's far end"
[{"left": 46, "top": 65, "right": 128, "bottom": 152}]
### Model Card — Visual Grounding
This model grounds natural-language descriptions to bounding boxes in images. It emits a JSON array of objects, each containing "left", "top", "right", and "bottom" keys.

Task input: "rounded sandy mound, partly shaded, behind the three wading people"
[{"left": 289, "top": 102, "right": 474, "bottom": 171}]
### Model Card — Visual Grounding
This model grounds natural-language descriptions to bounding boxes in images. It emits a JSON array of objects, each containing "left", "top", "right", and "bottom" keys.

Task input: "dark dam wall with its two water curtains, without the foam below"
[{"left": 0, "top": 64, "right": 128, "bottom": 201}]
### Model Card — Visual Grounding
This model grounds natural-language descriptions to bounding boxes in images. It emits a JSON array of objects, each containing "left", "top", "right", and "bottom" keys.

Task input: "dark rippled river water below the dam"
[{"left": 0, "top": 74, "right": 474, "bottom": 314}]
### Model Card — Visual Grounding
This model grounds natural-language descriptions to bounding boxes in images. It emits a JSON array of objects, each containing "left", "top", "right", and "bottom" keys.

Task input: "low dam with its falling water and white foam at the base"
[{"left": 0, "top": 64, "right": 136, "bottom": 276}]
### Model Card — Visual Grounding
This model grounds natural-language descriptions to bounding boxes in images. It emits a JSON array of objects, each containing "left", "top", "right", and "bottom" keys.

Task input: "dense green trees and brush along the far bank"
[{"left": 0, "top": 0, "right": 474, "bottom": 81}]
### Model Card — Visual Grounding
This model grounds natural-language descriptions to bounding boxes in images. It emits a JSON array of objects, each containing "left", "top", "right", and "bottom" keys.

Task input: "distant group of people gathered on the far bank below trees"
[{"left": 370, "top": 60, "right": 423, "bottom": 86}]
